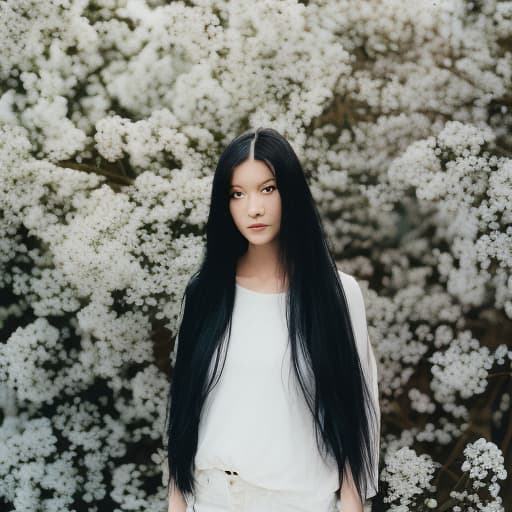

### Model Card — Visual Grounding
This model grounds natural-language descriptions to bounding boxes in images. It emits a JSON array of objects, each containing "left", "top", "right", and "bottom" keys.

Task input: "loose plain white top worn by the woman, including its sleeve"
[{"left": 190, "top": 271, "right": 380, "bottom": 498}]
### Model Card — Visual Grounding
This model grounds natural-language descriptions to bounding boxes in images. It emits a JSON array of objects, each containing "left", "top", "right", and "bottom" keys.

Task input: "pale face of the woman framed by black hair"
[{"left": 229, "top": 160, "right": 281, "bottom": 245}]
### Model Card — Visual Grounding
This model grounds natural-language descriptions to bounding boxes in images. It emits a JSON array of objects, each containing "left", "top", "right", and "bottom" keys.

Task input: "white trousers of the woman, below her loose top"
[{"left": 185, "top": 468, "right": 339, "bottom": 512}]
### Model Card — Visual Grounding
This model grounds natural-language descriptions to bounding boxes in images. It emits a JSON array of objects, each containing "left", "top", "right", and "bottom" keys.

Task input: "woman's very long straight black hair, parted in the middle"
[{"left": 166, "top": 128, "right": 377, "bottom": 501}]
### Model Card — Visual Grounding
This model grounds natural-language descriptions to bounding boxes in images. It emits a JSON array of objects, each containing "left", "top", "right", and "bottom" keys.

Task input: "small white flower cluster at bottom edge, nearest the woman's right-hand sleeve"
[{"left": 381, "top": 447, "right": 439, "bottom": 512}]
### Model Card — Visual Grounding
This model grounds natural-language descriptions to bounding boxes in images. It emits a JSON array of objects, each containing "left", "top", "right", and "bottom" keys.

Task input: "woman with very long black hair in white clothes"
[{"left": 167, "top": 128, "right": 380, "bottom": 512}]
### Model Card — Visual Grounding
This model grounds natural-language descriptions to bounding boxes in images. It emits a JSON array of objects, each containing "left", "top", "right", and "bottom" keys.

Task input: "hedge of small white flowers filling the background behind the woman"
[{"left": 0, "top": 0, "right": 512, "bottom": 512}]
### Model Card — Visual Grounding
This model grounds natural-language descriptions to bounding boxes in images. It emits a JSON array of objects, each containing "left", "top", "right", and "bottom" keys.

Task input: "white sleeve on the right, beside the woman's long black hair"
[{"left": 338, "top": 270, "right": 381, "bottom": 499}]
